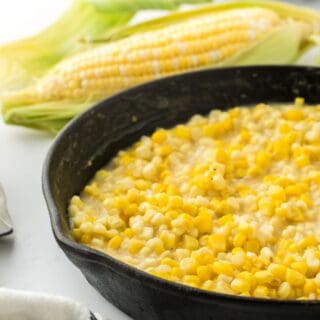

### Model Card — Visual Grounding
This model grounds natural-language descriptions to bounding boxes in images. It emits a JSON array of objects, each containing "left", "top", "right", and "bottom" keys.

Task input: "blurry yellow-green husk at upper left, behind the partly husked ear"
[{"left": 0, "top": 0, "right": 209, "bottom": 91}]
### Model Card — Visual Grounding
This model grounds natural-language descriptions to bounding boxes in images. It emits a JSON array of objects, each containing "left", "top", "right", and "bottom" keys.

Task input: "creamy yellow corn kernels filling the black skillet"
[{"left": 69, "top": 98, "right": 320, "bottom": 299}]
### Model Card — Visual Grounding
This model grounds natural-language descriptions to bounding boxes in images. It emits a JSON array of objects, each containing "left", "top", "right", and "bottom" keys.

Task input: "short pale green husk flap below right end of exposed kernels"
[{"left": 222, "top": 22, "right": 302, "bottom": 66}]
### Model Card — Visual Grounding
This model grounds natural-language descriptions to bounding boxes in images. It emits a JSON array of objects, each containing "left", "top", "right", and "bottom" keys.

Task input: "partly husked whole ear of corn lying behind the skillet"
[{"left": 2, "top": 1, "right": 320, "bottom": 131}]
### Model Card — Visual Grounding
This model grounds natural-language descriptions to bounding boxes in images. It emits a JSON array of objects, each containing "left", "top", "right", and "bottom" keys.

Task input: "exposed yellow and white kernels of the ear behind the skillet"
[{"left": 9, "top": 8, "right": 281, "bottom": 102}]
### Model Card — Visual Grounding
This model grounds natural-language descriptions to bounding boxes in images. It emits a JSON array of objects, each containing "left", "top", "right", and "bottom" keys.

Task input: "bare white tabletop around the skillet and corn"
[{"left": 0, "top": 0, "right": 320, "bottom": 320}]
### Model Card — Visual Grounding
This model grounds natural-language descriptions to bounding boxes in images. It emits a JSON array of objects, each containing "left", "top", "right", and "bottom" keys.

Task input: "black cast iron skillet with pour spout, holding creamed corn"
[{"left": 43, "top": 66, "right": 320, "bottom": 320}]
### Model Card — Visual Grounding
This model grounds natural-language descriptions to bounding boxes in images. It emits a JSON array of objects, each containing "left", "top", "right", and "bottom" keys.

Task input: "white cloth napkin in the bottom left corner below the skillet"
[{"left": 0, "top": 288, "right": 102, "bottom": 320}]
